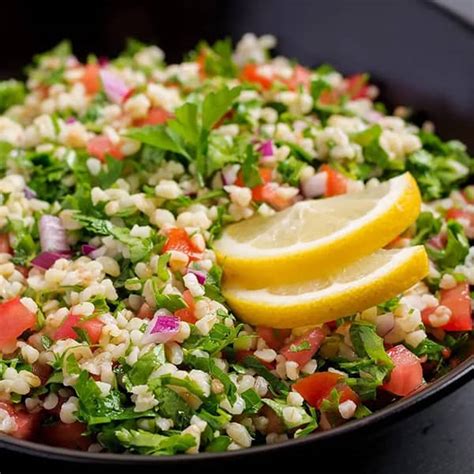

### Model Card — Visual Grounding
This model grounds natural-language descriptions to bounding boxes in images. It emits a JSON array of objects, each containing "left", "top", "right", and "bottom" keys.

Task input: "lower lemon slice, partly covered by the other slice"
[{"left": 223, "top": 245, "right": 428, "bottom": 328}]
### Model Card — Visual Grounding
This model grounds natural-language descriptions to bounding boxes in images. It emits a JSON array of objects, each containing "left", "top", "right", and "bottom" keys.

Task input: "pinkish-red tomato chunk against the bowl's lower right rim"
[{"left": 382, "top": 344, "right": 423, "bottom": 397}]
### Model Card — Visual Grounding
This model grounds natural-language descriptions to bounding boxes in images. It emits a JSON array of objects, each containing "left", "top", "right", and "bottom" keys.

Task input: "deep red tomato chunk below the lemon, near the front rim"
[{"left": 293, "top": 372, "right": 360, "bottom": 408}]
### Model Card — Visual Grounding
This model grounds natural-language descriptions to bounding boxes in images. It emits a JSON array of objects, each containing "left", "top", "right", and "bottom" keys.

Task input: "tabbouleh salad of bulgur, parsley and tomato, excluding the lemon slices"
[{"left": 0, "top": 34, "right": 474, "bottom": 455}]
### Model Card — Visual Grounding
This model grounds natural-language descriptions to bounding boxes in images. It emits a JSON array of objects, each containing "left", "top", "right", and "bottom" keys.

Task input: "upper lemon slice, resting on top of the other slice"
[{"left": 214, "top": 173, "right": 421, "bottom": 288}]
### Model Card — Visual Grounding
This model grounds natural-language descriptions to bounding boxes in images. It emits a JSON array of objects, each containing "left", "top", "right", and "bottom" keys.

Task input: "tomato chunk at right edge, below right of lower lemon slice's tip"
[{"left": 421, "top": 282, "right": 472, "bottom": 331}]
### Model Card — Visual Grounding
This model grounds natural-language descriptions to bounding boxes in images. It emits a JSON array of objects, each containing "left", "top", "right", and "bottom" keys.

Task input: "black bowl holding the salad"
[{"left": 0, "top": 0, "right": 474, "bottom": 473}]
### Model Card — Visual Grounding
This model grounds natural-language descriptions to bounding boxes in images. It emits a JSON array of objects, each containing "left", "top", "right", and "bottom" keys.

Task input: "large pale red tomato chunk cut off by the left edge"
[{"left": 0, "top": 298, "right": 36, "bottom": 350}]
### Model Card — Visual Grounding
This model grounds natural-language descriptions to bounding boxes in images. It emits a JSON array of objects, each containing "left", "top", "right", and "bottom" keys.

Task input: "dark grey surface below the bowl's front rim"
[{"left": 0, "top": 381, "right": 474, "bottom": 474}]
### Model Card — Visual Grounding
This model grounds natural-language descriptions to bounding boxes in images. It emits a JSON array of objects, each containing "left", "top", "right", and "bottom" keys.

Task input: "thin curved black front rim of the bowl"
[{"left": 0, "top": 355, "right": 474, "bottom": 466}]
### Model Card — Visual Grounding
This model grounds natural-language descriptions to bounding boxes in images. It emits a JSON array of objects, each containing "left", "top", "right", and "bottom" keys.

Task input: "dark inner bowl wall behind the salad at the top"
[{"left": 0, "top": 0, "right": 474, "bottom": 150}]
